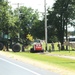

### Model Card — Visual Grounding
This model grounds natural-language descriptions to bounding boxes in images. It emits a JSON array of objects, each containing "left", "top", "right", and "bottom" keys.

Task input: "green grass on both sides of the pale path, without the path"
[{"left": 5, "top": 43, "right": 75, "bottom": 70}]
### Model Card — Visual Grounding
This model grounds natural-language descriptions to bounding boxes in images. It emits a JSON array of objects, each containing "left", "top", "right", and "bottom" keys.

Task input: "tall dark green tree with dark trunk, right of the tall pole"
[{"left": 49, "top": 0, "right": 75, "bottom": 49}]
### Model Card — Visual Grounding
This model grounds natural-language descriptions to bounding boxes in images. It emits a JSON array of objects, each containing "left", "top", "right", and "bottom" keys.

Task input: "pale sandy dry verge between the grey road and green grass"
[{"left": 0, "top": 51, "right": 75, "bottom": 75}]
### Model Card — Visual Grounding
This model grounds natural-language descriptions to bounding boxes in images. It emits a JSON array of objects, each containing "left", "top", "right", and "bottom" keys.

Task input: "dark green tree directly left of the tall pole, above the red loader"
[{"left": 31, "top": 20, "right": 45, "bottom": 39}]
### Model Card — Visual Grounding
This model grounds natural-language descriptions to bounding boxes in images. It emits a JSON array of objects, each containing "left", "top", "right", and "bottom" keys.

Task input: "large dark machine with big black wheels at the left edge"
[{"left": 0, "top": 38, "right": 21, "bottom": 52}]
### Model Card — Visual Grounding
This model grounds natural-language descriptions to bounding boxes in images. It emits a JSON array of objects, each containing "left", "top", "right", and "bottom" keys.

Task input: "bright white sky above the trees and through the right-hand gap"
[{"left": 8, "top": 0, "right": 74, "bottom": 31}]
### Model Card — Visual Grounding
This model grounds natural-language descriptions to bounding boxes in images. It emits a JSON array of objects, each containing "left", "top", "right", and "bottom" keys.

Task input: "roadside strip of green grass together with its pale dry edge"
[{"left": 0, "top": 51, "right": 75, "bottom": 75}]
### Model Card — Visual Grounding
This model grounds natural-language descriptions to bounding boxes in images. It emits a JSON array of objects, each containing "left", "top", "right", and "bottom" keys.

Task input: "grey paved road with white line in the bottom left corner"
[{"left": 0, "top": 55, "right": 59, "bottom": 75}]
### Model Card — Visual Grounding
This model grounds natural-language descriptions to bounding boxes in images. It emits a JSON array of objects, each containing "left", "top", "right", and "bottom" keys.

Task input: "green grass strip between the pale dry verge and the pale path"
[{"left": 9, "top": 52, "right": 75, "bottom": 70}]
